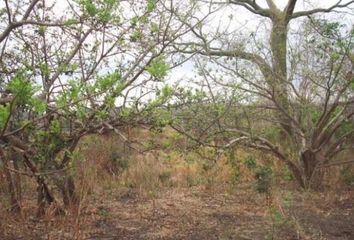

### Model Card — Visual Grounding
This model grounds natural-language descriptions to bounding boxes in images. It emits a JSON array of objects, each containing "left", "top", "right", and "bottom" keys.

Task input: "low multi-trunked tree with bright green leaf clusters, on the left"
[{"left": 0, "top": 0, "right": 199, "bottom": 214}]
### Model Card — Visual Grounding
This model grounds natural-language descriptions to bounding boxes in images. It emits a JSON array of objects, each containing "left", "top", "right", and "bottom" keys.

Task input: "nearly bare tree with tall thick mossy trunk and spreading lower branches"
[{"left": 176, "top": 0, "right": 354, "bottom": 188}]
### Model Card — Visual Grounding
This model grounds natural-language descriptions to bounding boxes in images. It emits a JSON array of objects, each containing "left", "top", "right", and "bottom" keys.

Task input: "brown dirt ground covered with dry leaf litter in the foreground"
[{"left": 0, "top": 188, "right": 354, "bottom": 240}]
